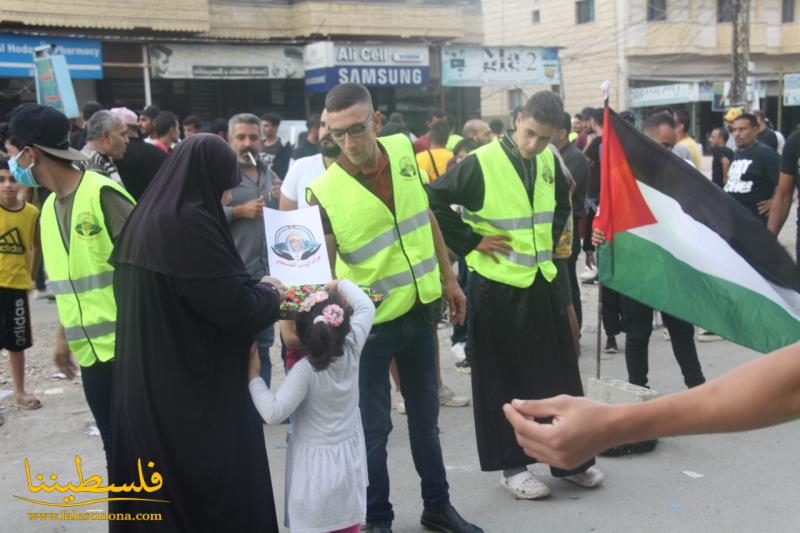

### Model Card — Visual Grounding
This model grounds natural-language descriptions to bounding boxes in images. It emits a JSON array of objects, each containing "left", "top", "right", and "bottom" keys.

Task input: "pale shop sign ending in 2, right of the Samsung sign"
[{"left": 442, "top": 46, "right": 561, "bottom": 87}]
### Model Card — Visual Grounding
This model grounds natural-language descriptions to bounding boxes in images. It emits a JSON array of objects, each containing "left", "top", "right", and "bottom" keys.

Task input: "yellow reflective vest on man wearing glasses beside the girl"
[{"left": 308, "top": 134, "right": 442, "bottom": 324}]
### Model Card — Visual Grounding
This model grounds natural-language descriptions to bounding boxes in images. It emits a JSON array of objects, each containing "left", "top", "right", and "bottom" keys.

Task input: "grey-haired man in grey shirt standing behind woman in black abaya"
[{"left": 224, "top": 113, "right": 280, "bottom": 386}]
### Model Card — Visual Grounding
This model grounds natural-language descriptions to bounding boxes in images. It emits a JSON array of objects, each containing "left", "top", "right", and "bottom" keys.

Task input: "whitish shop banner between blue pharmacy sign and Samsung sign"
[{"left": 149, "top": 43, "right": 303, "bottom": 80}]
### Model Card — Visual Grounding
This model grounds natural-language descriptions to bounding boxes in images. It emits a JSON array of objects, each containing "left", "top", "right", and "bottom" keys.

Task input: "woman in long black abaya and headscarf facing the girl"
[{"left": 109, "top": 135, "right": 282, "bottom": 532}]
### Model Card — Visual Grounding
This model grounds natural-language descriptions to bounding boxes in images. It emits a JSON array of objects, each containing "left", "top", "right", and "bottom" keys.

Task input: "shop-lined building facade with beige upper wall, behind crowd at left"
[{"left": 0, "top": 0, "right": 483, "bottom": 129}]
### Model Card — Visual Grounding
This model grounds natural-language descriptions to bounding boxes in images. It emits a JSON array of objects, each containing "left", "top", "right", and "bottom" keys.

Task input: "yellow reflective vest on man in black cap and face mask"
[{"left": 41, "top": 171, "right": 134, "bottom": 367}]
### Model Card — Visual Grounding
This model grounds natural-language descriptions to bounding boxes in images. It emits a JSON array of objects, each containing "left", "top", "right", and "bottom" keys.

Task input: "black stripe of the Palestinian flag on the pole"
[{"left": 601, "top": 109, "right": 800, "bottom": 292}]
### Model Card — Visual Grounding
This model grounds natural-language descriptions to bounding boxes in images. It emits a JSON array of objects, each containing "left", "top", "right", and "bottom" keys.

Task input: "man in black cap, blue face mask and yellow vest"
[{"left": 6, "top": 104, "right": 134, "bottom": 466}]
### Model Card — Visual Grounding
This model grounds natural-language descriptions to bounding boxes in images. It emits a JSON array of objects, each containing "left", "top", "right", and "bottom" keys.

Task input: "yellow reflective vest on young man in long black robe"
[{"left": 462, "top": 141, "right": 556, "bottom": 288}]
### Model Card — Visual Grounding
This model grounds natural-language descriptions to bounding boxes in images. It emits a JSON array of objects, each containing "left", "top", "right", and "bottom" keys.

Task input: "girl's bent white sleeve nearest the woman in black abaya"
[{"left": 248, "top": 361, "right": 313, "bottom": 424}]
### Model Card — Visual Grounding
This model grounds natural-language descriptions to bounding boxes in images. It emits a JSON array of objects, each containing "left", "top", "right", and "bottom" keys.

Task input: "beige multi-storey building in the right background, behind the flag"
[{"left": 482, "top": 0, "right": 800, "bottom": 138}]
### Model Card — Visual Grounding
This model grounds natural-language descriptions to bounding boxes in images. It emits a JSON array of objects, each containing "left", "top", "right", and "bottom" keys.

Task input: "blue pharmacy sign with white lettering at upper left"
[{"left": 0, "top": 33, "right": 103, "bottom": 80}]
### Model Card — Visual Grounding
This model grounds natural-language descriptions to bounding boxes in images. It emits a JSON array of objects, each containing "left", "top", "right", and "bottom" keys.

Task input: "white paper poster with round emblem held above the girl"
[{"left": 264, "top": 205, "right": 332, "bottom": 285}]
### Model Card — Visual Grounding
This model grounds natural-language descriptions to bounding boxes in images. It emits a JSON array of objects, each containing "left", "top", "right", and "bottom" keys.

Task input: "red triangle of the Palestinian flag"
[{"left": 592, "top": 107, "right": 658, "bottom": 242}]
